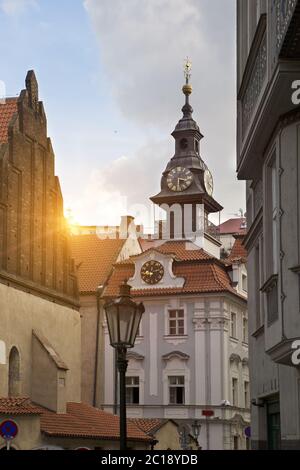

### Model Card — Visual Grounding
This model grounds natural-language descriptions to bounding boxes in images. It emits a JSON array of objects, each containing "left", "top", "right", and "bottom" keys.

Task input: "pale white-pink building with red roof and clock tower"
[{"left": 103, "top": 69, "right": 250, "bottom": 449}]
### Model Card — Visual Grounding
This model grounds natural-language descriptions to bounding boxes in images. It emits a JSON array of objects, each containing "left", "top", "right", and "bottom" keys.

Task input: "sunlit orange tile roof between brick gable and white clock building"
[{"left": 71, "top": 234, "right": 126, "bottom": 293}]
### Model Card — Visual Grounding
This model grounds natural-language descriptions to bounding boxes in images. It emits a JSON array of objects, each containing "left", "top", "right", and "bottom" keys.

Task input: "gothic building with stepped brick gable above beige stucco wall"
[{"left": 0, "top": 71, "right": 80, "bottom": 411}]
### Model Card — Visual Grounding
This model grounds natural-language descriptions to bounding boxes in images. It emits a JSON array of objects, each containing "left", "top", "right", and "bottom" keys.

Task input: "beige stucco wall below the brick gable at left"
[{"left": 0, "top": 284, "right": 81, "bottom": 402}]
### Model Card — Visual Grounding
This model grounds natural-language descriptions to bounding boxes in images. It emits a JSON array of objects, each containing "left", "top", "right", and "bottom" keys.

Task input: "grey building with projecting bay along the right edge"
[{"left": 237, "top": 0, "right": 300, "bottom": 450}]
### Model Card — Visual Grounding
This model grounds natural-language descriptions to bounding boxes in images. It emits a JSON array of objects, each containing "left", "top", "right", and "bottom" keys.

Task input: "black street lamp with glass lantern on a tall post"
[{"left": 104, "top": 282, "right": 145, "bottom": 450}]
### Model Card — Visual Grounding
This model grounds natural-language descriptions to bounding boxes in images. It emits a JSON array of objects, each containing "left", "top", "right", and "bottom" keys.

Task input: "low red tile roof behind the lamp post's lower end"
[{"left": 40, "top": 403, "right": 152, "bottom": 443}]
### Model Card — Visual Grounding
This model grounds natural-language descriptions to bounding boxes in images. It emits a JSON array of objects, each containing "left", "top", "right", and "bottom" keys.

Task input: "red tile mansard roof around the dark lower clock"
[{"left": 104, "top": 242, "right": 244, "bottom": 297}]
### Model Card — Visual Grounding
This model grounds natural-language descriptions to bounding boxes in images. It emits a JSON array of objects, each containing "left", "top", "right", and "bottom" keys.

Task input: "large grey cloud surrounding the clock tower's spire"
[{"left": 79, "top": 0, "right": 245, "bottom": 226}]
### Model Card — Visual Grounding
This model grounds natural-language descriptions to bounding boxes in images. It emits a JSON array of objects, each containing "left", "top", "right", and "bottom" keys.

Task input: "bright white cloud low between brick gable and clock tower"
[{"left": 65, "top": 141, "right": 169, "bottom": 228}]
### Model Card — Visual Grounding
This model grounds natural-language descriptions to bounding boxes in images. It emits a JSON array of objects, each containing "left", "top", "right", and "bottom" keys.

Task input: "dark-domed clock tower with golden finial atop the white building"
[{"left": 151, "top": 60, "right": 223, "bottom": 251}]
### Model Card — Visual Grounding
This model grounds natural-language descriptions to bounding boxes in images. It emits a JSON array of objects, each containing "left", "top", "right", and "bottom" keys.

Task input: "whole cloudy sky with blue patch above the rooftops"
[{"left": 0, "top": 0, "right": 245, "bottom": 228}]
